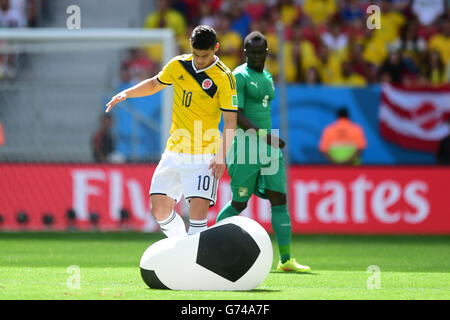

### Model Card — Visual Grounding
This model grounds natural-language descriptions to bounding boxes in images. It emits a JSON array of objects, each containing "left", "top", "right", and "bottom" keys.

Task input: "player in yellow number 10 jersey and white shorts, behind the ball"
[{"left": 106, "top": 26, "right": 238, "bottom": 237}]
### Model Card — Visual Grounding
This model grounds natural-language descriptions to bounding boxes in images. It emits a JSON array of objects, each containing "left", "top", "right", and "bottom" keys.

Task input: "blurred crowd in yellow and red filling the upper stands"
[{"left": 121, "top": 0, "right": 450, "bottom": 86}]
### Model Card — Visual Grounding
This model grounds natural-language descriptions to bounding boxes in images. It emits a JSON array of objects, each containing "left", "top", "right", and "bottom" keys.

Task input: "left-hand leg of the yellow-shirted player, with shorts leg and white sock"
[{"left": 150, "top": 153, "right": 186, "bottom": 237}]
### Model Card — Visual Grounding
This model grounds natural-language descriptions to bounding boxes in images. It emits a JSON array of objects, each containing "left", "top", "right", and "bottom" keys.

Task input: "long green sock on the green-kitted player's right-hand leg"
[{"left": 271, "top": 204, "right": 292, "bottom": 263}]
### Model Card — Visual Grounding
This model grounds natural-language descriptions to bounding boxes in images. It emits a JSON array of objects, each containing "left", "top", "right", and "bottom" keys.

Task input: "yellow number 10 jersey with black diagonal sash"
[{"left": 157, "top": 54, "right": 238, "bottom": 154}]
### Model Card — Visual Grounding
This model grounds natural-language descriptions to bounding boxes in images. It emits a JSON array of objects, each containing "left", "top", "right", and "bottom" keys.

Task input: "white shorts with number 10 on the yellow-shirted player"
[{"left": 150, "top": 150, "right": 219, "bottom": 207}]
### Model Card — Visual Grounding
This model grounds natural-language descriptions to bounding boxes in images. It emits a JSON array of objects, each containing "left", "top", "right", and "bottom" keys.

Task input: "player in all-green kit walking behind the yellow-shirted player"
[{"left": 216, "top": 31, "right": 311, "bottom": 273}]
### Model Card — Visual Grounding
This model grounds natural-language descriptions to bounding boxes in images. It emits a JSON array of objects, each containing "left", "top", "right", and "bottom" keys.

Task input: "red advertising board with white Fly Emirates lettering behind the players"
[{"left": 0, "top": 164, "right": 450, "bottom": 234}]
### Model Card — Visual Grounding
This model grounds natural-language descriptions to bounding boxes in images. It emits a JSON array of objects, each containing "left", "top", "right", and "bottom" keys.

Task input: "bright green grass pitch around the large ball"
[{"left": 0, "top": 233, "right": 450, "bottom": 300}]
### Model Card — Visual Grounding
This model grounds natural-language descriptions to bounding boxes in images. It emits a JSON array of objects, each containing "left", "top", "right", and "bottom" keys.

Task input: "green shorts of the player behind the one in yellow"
[{"left": 228, "top": 150, "right": 286, "bottom": 202}]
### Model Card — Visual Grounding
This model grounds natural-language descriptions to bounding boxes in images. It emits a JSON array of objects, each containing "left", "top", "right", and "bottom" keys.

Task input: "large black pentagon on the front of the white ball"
[{"left": 196, "top": 223, "right": 261, "bottom": 282}]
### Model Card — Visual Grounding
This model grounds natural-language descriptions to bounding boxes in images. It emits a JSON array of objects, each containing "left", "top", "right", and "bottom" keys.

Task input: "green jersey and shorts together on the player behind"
[{"left": 227, "top": 64, "right": 286, "bottom": 202}]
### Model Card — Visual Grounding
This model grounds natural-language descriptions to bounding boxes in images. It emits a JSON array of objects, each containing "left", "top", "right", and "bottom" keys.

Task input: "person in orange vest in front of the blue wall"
[{"left": 319, "top": 108, "right": 367, "bottom": 165}]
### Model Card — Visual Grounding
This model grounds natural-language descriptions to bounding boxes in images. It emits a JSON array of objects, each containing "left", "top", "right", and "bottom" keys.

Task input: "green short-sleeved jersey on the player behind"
[{"left": 233, "top": 63, "right": 275, "bottom": 133}]
